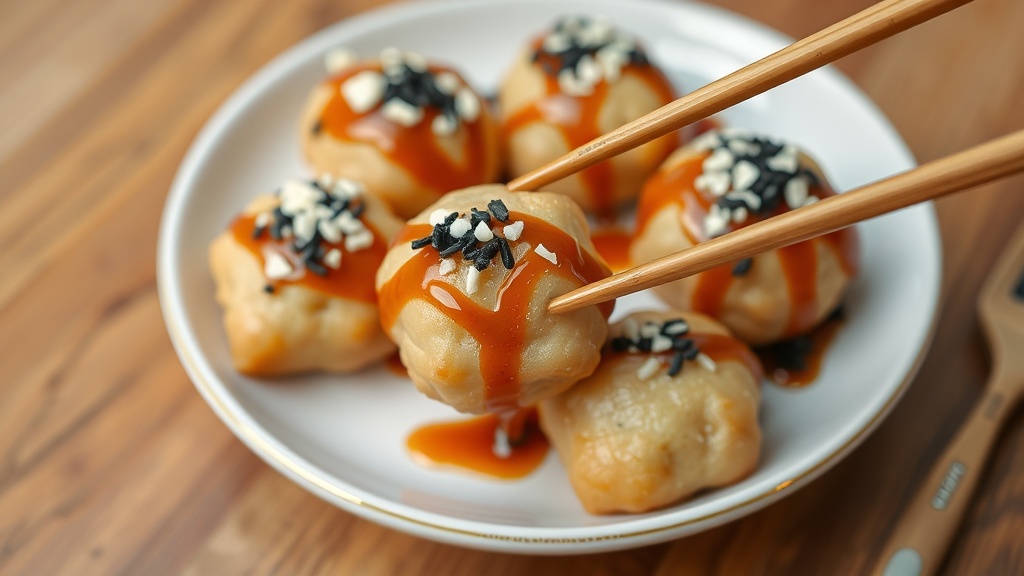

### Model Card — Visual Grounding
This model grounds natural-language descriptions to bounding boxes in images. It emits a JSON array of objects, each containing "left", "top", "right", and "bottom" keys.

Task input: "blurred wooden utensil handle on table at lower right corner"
[{"left": 872, "top": 370, "right": 1019, "bottom": 576}]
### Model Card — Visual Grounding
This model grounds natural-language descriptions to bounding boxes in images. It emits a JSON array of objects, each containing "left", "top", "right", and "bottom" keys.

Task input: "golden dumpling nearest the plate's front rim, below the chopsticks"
[{"left": 540, "top": 312, "right": 761, "bottom": 513}]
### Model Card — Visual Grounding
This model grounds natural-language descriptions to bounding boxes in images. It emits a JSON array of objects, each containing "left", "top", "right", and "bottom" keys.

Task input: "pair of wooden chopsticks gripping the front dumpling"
[{"left": 508, "top": 0, "right": 1024, "bottom": 313}]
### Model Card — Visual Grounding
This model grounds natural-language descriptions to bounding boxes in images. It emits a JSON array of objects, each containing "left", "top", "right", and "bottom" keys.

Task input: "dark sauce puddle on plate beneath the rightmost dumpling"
[{"left": 757, "top": 309, "right": 843, "bottom": 388}]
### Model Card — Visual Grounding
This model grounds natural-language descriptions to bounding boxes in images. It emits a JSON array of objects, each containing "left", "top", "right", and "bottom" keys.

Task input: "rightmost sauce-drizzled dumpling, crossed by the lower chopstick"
[{"left": 630, "top": 129, "right": 858, "bottom": 345}]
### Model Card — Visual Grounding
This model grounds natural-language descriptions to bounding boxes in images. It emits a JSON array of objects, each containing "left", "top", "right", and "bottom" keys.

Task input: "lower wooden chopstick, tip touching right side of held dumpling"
[{"left": 548, "top": 130, "right": 1024, "bottom": 313}]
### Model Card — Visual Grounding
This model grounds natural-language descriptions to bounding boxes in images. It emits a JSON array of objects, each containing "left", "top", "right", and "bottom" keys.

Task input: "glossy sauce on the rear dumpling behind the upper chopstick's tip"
[{"left": 502, "top": 38, "right": 676, "bottom": 213}]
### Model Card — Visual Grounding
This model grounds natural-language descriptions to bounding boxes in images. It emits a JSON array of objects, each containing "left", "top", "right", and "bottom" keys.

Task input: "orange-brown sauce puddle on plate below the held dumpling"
[{"left": 406, "top": 408, "right": 549, "bottom": 480}]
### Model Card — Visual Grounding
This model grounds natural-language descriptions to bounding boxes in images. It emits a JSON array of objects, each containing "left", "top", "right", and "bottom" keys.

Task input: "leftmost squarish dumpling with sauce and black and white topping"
[{"left": 210, "top": 177, "right": 401, "bottom": 376}]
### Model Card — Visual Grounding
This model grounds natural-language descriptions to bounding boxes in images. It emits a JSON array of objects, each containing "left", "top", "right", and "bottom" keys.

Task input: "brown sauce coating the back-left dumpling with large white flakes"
[{"left": 316, "top": 64, "right": 489, "bottom": 196}]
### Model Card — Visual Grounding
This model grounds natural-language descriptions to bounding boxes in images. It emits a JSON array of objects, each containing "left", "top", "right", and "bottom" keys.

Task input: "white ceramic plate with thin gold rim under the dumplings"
[{"left": 159, "top": 0, "right": 940, "bottom": 553}]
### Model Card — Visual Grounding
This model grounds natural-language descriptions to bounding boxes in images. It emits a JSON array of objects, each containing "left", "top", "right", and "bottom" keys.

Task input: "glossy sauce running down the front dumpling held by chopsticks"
[{"left": 380, "top": 212, "right": 614, "bottom": 412}]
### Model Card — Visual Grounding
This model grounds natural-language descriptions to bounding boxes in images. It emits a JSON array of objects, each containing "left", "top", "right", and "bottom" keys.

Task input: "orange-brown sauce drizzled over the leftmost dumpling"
[{"left": 230, "top": 214, "right": 387, "bottom": 303}]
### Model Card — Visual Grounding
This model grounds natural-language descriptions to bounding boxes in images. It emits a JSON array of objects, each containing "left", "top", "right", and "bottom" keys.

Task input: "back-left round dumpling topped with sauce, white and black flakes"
[{"left": 301, "top": 48, "right": 501, "bottom": 218}]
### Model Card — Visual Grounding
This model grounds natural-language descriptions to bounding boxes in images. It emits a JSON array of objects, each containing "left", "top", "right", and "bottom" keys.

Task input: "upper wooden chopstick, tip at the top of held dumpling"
[{"left": 508, "top": 0, "right": 972, "bottom": 191}]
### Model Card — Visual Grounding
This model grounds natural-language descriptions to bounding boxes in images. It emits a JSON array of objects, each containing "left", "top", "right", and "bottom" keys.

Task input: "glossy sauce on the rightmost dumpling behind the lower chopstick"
[{"left": 637, "top": 152, "right": 859, "bottom": 337}]
